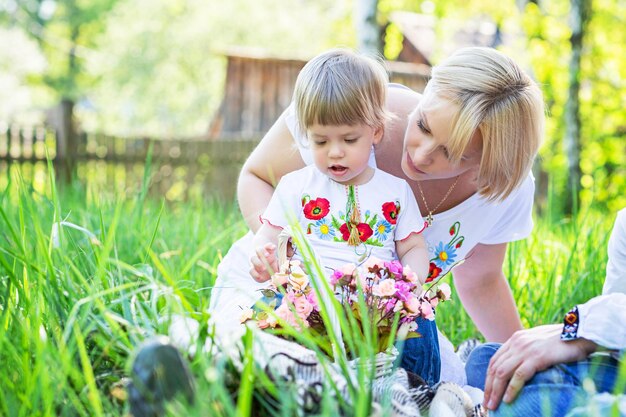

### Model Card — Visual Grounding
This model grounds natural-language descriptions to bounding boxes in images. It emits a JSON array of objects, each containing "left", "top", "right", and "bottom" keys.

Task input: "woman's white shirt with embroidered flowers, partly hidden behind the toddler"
[{"left": 285, "top": 103, "right": 535, "bottom": 280}]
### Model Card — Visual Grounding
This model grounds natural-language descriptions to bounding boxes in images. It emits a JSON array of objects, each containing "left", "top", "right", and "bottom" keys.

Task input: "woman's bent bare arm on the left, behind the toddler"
[{"left": 237, "top": 109, "right": 304, "bottom": 232}]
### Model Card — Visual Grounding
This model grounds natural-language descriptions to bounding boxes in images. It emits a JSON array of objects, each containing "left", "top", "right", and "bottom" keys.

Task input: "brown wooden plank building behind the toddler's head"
[{"left": 209, "top": 51, "right": 430, "bottom": 139}]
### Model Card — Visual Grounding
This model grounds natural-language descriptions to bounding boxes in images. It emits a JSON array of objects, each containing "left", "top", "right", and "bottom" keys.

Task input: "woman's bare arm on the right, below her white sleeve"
[{"left": 454, "top": 243, "right": 522, "bottom": 343}]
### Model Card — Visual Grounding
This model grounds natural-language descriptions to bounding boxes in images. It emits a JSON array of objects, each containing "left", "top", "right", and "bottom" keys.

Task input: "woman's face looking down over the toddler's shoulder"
[{"left": 402, "top": 94, "right": 482, "bottom": 181}]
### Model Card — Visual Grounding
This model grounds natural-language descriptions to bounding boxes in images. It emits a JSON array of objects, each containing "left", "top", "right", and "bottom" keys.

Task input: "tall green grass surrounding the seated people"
[{"left": 0, "top": 164, "right": 614, "bottom": 416}]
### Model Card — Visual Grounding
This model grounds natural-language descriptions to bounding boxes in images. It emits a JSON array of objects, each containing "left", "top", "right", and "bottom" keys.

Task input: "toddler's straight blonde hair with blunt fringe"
[{"left": 293, "top": 49, "right": 389, "bottom": 132}]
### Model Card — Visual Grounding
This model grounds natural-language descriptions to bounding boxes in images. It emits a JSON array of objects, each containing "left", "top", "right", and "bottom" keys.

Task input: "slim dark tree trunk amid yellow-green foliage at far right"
[{"left": 563, "top": 0, "right": 591, "bottom": 214}]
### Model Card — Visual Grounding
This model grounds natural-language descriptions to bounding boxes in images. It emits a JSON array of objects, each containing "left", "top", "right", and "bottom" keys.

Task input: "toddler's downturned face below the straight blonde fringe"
[{"left": 307, "top": 124, "right": 383, "bottom": 185}]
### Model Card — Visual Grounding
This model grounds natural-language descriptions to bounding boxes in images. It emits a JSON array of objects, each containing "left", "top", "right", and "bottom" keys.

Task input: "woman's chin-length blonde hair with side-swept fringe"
[{"left": 425, "top": 47, "right": 545, "bottom": 200}]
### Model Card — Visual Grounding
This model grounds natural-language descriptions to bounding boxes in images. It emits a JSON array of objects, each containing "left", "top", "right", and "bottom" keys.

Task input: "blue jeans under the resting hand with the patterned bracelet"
[{"left": 465, "top": 343, "right": 619, "bottom": 417}]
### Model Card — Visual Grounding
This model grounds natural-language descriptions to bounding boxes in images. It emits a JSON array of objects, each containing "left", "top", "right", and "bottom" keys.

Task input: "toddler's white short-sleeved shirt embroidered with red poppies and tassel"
[{"left": 261, "top": 165, "right": 424, "bottom": 269}]
